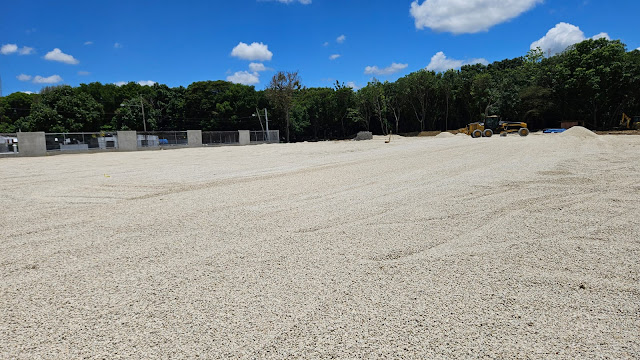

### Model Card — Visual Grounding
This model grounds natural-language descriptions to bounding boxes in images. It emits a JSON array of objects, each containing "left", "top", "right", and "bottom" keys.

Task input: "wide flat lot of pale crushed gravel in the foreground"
[{"left": 0, "top": 134, "right": 640, "bottom": 359}]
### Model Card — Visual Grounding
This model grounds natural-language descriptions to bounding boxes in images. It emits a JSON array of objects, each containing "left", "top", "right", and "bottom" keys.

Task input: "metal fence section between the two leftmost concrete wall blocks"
[{"left": 44, "top": 132, "right": 118, "bottom": 151}]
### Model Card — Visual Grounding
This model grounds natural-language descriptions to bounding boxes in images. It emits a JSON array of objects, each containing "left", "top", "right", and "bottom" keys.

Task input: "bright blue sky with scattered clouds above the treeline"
[{"left": 0, "top": 0, "right": 640, "bottom": 95}]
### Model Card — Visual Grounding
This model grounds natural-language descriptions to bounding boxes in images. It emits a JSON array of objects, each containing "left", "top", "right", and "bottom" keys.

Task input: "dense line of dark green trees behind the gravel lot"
[{"left": 0, "top": 39, "right": 640, "bottom": 141}]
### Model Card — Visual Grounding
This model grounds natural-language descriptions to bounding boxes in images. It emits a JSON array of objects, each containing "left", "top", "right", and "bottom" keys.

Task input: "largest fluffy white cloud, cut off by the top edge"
[{"left": 409, "top": 0, "right": 543, "bottom": 34}]
